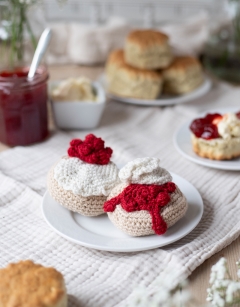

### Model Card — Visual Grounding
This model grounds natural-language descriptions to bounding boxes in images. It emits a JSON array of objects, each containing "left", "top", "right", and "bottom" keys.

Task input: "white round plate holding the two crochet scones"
[{"left": 42, "top": 173, "right": 203, "bottom": 252}]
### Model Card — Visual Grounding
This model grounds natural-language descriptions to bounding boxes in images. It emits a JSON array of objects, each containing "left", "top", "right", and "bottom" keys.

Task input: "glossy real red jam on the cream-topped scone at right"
[{"left": 190, "top": 113, "right": 222, "bottom": 140}]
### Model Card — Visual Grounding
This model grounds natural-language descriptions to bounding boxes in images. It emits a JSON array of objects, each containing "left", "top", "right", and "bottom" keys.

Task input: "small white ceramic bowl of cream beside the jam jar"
[{"left": 51, "top": 82, "right": 106, "bottom": 129}]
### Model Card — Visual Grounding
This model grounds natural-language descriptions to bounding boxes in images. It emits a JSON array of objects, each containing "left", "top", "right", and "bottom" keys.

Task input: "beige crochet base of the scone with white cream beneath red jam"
[{"left": 47, "top": 166, "right": 107, "bottom": 216}]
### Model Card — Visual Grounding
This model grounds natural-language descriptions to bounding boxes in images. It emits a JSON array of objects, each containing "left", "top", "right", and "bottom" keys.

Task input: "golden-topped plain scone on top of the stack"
[{"left": 124, "top": 30, "right": 173, "bottom": 69}]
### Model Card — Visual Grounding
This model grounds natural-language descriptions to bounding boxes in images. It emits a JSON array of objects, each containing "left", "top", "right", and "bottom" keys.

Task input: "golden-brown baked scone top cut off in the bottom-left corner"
[{"left": 0, "top": 260, "right": 67, "bottom": 307}]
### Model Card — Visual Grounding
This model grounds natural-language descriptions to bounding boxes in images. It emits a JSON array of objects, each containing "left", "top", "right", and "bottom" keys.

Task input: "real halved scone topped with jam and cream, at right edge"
[{"left": 190, "top": 113, "right": 240, "bottom": 160}]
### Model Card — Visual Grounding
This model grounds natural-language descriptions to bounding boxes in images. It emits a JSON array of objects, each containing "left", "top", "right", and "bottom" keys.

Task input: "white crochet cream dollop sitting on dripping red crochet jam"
[{"left": 119, "top": 157, "right": 172, "bottom": 184}]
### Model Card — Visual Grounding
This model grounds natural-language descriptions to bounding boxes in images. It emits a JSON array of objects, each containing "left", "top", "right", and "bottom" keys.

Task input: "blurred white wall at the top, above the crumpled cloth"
[{"left": 44, "top": 0, "right": 227, "bottom": 26}]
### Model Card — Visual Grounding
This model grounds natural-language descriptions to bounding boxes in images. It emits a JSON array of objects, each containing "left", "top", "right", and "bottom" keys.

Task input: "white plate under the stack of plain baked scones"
[{"left": 99, "top": 75, "right": 212, "bottom": 106}]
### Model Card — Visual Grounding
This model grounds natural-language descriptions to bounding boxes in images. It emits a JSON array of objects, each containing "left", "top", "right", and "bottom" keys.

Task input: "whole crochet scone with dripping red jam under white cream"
[{"left": 104, "top": 157, "right": 188, "bottom": 236}]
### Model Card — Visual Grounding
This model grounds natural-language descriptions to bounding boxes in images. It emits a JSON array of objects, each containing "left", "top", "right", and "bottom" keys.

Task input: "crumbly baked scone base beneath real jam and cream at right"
[{"left": 191, "top": 134, "right": 240, "bottom": 160}]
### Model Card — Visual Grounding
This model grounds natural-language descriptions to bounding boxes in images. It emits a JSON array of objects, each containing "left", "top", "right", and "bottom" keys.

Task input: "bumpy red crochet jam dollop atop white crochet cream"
[{"left": 68, "top": 134, "right": 113, "bottom": 165}]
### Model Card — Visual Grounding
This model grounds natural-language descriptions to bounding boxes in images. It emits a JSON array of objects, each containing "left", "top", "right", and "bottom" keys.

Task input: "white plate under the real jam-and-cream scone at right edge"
[{"left": 173, "top": 106, "right": 240, "bottom": 172}]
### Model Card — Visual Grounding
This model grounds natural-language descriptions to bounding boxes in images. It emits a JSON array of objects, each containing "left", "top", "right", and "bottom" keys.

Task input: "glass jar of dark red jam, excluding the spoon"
[{"left": 0, "top": 66, "right": 48, "bottom": 146}]
